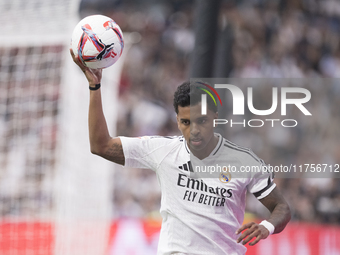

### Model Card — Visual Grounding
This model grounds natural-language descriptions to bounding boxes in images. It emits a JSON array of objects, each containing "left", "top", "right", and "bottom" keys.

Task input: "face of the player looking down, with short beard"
[{"left": 177, "top": 103, "right": 218, "bottom": 159}]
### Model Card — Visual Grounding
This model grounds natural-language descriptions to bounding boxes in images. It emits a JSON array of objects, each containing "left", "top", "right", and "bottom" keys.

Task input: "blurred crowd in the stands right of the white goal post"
[{"left": 81, "top": 0, "right": 340, "bottom": 223}]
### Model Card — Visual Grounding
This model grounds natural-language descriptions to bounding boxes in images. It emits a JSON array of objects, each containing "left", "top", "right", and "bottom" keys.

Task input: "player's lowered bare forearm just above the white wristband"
[{"left": 268, "top": 203, "right": 291, "bottom": 234}]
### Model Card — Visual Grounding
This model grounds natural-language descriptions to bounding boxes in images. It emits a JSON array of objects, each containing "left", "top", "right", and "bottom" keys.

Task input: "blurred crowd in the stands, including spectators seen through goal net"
[{"left": 0, "top": 0, "right": 340, "bottom": 223}]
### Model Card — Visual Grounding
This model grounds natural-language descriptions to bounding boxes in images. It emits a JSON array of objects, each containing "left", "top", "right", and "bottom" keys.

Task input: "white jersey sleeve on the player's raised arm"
[{"left": 119, "top": 136, "right": 174, "bottom": 171}]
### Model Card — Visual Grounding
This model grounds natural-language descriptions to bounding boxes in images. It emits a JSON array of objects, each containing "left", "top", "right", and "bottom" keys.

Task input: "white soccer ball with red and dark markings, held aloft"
[{"left": 72, "top": 15, "right": 124, "bottom": 69}]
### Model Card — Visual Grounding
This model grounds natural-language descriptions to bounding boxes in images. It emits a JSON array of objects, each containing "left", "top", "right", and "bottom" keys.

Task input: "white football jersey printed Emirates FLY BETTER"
[{"left": 120, "top": 134, "right": 275, "bottom": 255}]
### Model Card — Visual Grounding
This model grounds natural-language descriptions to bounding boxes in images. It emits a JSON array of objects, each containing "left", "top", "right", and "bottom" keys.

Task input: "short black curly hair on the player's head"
[{"left": 174, "top": 81, "right": 217, "bottom": 114}]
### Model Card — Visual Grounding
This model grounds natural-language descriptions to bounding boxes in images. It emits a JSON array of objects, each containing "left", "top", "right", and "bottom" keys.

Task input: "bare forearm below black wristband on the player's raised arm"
[{"left": 89, "top": 89, "right": 110, "bottom": 154}]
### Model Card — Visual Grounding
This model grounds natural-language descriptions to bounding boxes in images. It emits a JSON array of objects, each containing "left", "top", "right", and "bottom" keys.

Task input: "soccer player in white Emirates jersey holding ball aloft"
[{"left": 71, "top": 50, "right": 290, "bottom": 255}]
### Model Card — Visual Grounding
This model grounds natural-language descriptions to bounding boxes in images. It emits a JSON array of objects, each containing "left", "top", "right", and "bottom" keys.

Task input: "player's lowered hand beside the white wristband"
[{"left": 236, "top": 222, "right": 269, "bottom": 246}]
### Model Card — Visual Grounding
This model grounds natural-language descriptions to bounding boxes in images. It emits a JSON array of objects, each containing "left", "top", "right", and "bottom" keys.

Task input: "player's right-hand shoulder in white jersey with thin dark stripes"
[{"left": 223, "top": 138, "right": 264, "bottom": 164}]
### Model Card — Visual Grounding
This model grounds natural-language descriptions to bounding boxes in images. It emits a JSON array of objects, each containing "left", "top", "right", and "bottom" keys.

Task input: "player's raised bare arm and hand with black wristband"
[{"left": 70, "top": 49, "right": 125, "bottom": 165}]
